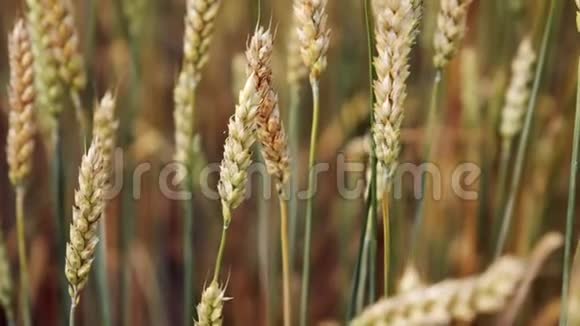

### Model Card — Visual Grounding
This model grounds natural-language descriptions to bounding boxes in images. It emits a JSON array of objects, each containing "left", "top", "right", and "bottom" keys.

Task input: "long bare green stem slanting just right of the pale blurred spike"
[{"left": 494, "top": 0, "right": 558, "bottom": 259}]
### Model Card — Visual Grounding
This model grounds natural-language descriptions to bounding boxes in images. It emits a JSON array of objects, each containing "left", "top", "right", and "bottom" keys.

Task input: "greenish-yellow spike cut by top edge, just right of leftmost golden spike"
[{"left": 26, "top": 0, "right": 64, "bottom": 117}]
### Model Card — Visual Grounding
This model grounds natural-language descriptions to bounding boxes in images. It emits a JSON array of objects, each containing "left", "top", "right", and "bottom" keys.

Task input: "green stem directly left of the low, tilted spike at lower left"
[{"left": 52, "top": 120, "right": 70, "bottom": 325}]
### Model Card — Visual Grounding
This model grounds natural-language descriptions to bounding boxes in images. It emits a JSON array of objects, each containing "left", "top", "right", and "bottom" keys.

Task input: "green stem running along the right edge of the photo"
[{"left": 560, "top": 60, "right": 580, "bottom": 326}]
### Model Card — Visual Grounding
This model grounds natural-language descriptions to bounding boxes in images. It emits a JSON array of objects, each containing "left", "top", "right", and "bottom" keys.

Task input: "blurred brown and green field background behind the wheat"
[{"left": 0, "top": 0, "right": 578, "bottom": 325}]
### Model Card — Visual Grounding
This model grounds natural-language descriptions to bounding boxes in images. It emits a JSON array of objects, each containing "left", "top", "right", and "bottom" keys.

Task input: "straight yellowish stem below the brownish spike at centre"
[{"left": 278, "top": 196, "right": 292, "bottom": 326}]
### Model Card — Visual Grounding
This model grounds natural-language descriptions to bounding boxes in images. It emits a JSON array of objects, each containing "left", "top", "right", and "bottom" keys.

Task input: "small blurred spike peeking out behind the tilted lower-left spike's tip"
[{"left": 93, "top": 92, "right": 119, "bottom": 181}]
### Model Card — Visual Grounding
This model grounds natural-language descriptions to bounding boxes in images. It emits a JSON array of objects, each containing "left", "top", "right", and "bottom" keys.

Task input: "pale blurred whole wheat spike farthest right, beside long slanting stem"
[{"left": 499, "top": 37, "right": 536, "bottom": 140}]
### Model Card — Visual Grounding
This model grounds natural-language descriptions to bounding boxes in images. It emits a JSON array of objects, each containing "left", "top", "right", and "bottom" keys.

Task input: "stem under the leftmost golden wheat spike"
[{"left": 16, "top": 186, "right": 30, "bottom": 326}]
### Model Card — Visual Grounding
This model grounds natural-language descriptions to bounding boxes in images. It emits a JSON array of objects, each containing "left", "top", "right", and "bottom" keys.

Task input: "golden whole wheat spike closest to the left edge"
[{"left": 6, "top": 19, "right": 36, "bottom": 187}]
